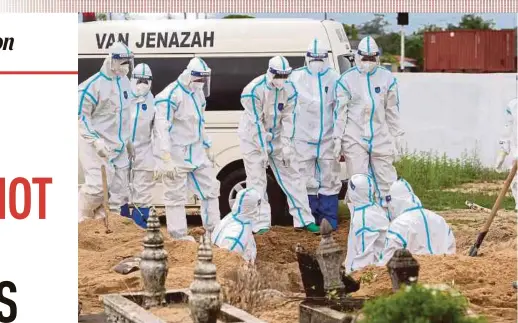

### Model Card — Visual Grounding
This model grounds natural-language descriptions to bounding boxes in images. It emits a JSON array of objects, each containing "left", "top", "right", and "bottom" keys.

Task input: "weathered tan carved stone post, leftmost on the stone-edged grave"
[{"left": 140, "top": 208, "right": 168, "bottom": 308}]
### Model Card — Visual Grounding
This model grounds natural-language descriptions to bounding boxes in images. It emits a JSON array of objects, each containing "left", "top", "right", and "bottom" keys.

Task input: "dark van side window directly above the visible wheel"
[{"left": 200, "top": 55, "right": 304, "bottom": 111}]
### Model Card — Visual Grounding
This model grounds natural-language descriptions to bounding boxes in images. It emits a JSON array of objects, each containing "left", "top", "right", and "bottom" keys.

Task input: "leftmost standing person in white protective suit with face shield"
[{"left": 78, "top": 42, "right": 134, "bottom": 222}]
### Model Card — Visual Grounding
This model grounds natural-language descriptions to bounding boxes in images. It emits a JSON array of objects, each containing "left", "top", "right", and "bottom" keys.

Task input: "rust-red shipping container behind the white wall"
[{"left": 424, "top": 29, "right": 516, "bottom": 73}]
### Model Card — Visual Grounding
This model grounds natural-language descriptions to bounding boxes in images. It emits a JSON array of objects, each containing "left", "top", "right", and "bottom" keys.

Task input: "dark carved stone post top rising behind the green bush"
[{"left": 387, "top": 249, "right": 419, "bottom": 292}]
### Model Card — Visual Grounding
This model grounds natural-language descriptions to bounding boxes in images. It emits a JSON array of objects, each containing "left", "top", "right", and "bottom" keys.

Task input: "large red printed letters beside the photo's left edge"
[{"left": 0, "top": 177, "right": 52, "bottom": 220}]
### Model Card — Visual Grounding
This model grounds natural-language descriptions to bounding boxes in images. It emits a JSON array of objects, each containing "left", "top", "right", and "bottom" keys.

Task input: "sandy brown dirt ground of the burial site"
[{"left": 78, "top": 210, "right": 517, "bottom": 323}]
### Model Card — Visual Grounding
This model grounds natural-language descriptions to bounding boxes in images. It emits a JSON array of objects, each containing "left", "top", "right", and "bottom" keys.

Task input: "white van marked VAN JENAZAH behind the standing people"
[{"left": 79, "top": 19, "right": 353, "bottom": 224}]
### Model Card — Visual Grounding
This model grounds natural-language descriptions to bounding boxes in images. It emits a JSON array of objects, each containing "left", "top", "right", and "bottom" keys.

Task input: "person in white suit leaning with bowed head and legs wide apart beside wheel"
[{"left": 238, "top": 56, "right": 319, "bottom": 234}]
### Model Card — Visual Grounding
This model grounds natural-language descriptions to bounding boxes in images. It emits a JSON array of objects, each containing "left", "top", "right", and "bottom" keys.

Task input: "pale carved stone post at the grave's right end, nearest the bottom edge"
[{"left": 189, "top": 231, "right": 222, "bottom": 323}]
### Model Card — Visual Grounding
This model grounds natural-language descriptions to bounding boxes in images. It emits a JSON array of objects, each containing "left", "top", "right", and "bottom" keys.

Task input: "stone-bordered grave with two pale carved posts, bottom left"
[{"left": 101, "top": 210, "right": 266, "bottom": 323}]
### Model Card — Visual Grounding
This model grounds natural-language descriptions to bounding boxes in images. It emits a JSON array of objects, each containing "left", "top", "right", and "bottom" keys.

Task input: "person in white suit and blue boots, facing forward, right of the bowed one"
[{"left": 290, "top": 38, "right": 342, "bottom": 230}]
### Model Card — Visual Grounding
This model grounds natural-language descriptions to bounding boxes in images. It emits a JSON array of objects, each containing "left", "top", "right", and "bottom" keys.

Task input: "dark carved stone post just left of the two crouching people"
[{"left": 316, "top": 219, "right": 345, "bottom": 292}]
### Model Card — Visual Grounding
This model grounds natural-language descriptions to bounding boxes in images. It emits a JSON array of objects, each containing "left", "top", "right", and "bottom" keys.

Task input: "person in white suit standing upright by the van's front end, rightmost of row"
[{"left": 333, "top": 36, "right": 404, "bottom": 208}]
